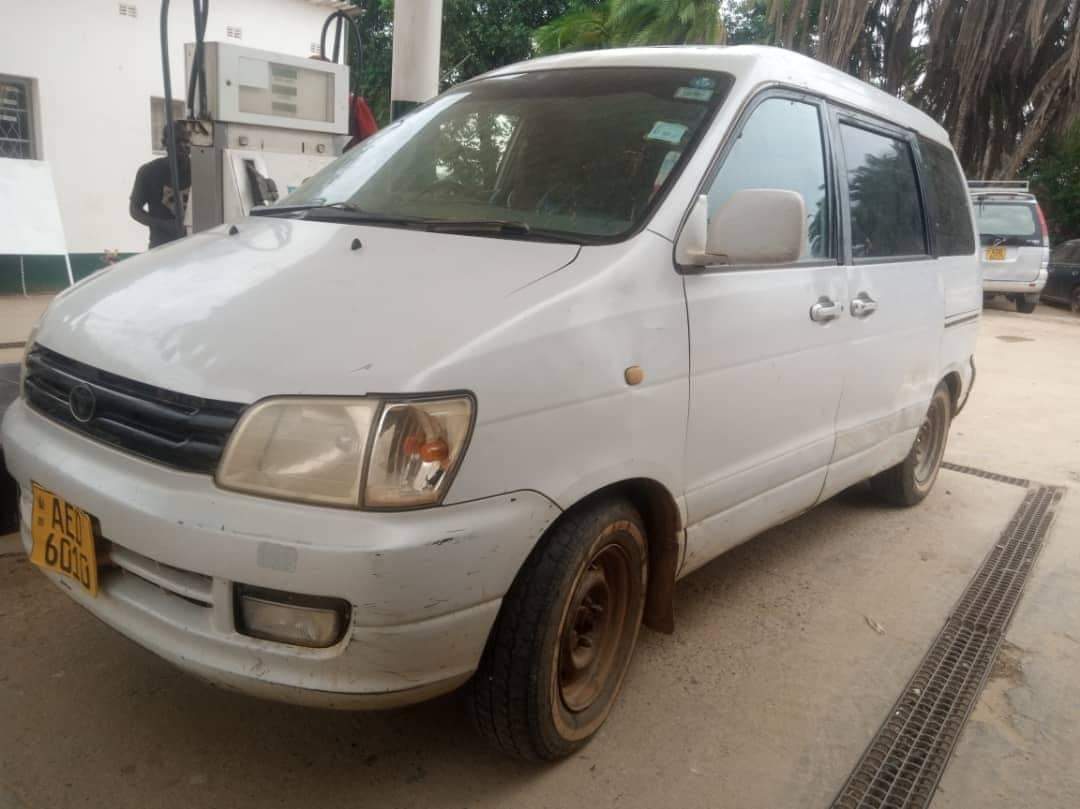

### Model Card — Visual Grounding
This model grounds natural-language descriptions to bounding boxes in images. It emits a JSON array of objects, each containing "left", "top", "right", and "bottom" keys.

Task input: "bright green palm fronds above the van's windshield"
[{"left": 536, "top": 0, "right": 725, "bottom": 53}]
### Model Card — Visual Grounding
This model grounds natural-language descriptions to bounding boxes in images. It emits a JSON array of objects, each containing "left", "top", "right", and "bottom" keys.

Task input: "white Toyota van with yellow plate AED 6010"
[{"left": 3, "top": 48, "right": 982, "bottom": 759}]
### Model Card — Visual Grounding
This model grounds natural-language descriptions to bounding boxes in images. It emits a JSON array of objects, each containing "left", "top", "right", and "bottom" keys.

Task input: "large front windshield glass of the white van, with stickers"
[{"left": 278, "top": 68, "right": 731, "bottom": 241}]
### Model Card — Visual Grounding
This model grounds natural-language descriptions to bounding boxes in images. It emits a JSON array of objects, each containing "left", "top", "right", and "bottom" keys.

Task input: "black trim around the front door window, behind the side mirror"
[{"left": 674, "top": 83, "right": 842, "bottom": 275}]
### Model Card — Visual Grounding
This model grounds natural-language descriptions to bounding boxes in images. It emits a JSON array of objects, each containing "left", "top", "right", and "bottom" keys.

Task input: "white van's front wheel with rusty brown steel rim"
[{"left": 464, "top": 498, "right": 648, "bottom": 761}]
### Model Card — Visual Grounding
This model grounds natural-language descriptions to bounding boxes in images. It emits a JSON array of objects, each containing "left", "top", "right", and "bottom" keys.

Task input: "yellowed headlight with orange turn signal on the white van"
[{"left": 217, "top": 396, "right": 473, "bottom": 509}]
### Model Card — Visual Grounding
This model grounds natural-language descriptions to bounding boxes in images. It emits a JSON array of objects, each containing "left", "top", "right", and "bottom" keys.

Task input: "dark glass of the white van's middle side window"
[{"left": 840, "top": 124, "right": 927, "bottom": 258}]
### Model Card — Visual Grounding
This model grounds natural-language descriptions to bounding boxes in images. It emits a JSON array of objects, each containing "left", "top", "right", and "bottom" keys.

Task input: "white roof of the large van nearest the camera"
[{"left": 487, "top": 45, "right": 949, "bottom": 144}]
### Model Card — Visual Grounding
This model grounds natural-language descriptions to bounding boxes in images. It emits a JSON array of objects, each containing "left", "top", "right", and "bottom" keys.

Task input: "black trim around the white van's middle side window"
[{"left": 828, "top": 102, "right": 937, "bottom": 267}]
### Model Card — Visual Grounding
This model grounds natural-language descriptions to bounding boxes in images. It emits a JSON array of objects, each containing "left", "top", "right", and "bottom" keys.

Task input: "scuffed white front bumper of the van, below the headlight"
[{"left": 3, "top": 401, "right": 558, "bottom": 707}]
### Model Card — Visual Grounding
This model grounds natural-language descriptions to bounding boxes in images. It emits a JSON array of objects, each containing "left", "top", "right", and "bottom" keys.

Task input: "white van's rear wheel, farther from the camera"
[{"left": 870, "top": 383, "right": 953, "bottom": 507}]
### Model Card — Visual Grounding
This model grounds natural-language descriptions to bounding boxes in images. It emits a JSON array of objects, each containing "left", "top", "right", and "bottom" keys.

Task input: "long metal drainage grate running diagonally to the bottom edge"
[{"left": 833, "top": 483, "right": 1064, "bottom": 809}]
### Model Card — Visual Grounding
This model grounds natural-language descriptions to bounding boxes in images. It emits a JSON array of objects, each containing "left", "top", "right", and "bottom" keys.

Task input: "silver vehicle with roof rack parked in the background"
[{"left": 969, "top": 180, "right": 1050, "bottom": 314}]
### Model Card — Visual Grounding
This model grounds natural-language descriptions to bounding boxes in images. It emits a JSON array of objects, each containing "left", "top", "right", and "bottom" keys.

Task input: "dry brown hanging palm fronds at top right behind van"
[{"left": 764, "top": 0, "right": 1080, "bottom": 177}]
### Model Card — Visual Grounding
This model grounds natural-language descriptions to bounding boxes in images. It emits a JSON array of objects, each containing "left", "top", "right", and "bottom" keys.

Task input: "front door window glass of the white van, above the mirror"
[{"left": 708, "top": 98, "right": 834, "bottom": 258}]
